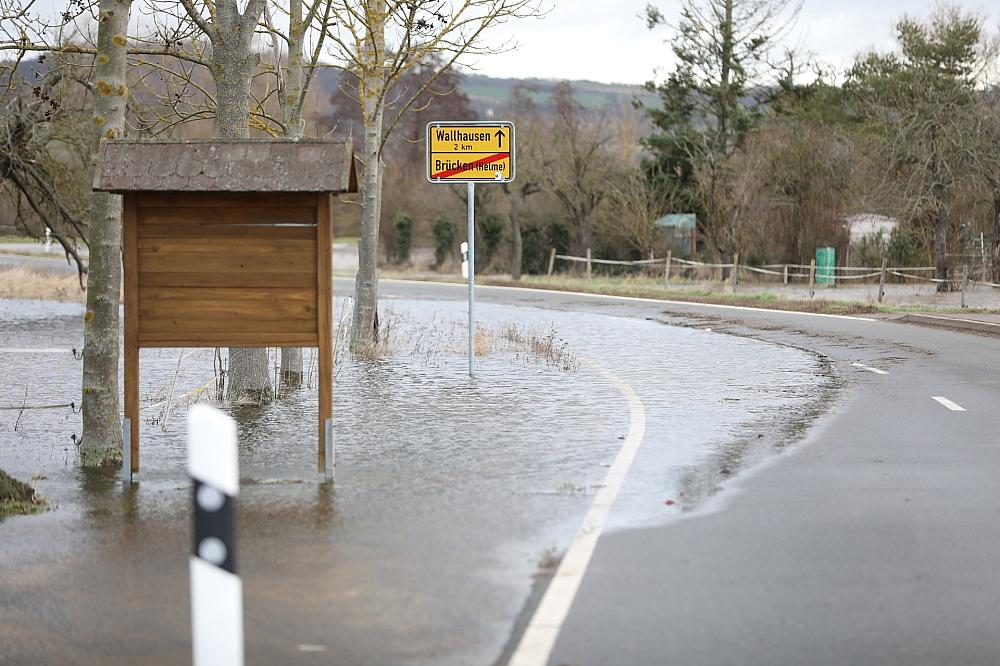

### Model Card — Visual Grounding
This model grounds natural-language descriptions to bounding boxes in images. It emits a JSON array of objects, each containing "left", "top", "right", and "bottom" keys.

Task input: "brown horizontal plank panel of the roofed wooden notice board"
[{"left": 136, "top": 194, "right": 322, "bottom": 347}]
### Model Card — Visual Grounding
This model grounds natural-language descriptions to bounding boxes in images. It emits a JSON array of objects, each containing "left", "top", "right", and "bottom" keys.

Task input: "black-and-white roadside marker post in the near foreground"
[{"left": 188, "top": 405, "right": 243, "bottom": 666}]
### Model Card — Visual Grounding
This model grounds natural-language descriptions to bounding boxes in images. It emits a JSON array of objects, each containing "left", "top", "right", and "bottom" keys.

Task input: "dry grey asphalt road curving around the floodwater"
[{"left": 360, "top": 282, "right": 1000, "bottom": 666}]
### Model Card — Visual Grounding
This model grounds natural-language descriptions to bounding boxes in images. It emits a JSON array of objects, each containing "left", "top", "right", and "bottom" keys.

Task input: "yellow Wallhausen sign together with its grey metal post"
[{"left": 426, "top": 121, "right": 516, "bottom": 377}]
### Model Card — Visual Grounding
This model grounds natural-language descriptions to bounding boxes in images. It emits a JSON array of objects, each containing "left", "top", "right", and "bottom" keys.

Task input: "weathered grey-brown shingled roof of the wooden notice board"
[{"left": 94, "top": 140, "right": 358, "bottom": 193}]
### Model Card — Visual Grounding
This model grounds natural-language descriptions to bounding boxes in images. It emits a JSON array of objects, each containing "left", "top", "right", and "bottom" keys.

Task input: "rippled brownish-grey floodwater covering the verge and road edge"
[{"left": 0, "top": 300, "right": 832, "bottom": 666}]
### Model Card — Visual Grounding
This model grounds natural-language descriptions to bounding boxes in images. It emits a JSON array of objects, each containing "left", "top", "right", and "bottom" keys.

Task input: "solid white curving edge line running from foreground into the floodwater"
[{"left": 508, "top": 361, "right": 646, "bottom": 666}]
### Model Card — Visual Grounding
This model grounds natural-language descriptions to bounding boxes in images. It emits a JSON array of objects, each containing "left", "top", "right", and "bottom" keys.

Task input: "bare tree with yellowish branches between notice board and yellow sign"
[{"left": 328, "top": 0, "right": 539, "bottom": 350}]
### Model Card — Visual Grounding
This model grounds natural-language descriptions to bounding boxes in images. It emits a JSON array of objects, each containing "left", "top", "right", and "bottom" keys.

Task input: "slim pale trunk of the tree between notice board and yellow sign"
[{"left": 351, "top": 0, "right": 386, "bottom": 351}]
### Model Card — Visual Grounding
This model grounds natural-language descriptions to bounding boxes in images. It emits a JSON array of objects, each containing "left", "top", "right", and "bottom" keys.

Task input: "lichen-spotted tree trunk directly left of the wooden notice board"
[{"left": 80, "top": 0, "right": 132, "bottom": 466}]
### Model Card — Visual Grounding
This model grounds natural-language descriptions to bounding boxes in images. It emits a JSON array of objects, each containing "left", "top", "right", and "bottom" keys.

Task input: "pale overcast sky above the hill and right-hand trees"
[{"left": 464, "top": 0, "right": 998, "bottom": 83}]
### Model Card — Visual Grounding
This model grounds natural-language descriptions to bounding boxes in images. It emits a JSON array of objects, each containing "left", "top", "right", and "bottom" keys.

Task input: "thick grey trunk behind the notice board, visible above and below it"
[{"left": 212, "top": 2, "right": 274, "bottom": 404}]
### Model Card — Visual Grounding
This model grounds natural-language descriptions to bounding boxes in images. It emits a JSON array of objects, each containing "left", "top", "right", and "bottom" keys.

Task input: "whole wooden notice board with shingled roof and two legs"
[{"left": 94, "top": 141, "right": 357, "bottom": 478}]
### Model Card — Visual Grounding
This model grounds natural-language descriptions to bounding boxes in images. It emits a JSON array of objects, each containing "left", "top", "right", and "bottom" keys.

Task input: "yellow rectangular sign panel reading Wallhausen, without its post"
[{"left": 427, "top": 121, "right": 515, "bottom": 183}]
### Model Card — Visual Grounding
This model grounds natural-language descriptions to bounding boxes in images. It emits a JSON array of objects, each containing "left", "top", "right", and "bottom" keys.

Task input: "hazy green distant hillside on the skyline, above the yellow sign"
[{"left": 461, "top": 74, "right": 657, "bottom": 117}]
